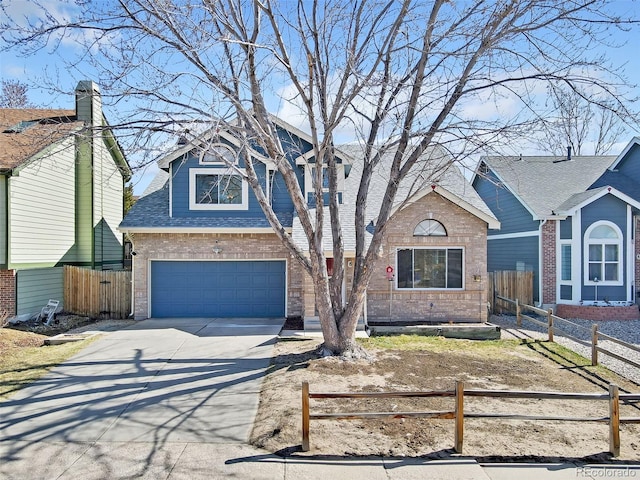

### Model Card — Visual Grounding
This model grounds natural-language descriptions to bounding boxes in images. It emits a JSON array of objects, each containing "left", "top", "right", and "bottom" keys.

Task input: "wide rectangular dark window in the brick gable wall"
[{"left": 396, "top": 247, "right": 464, "bottom": 290}]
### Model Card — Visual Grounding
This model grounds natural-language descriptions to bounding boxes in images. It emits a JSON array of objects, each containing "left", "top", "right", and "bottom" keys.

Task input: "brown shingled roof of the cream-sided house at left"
[{"left": 0, "top": 108, "right": 84, "bottom": 170}]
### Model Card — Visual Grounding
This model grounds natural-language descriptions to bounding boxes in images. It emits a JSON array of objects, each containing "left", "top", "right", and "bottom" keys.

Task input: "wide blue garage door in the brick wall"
[{"left": 151, "top": 261, "right": 285, "bottom": 318}]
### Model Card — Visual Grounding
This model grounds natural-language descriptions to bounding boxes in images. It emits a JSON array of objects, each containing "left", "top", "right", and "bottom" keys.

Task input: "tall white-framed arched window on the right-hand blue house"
[{"left": 584, "top": 221, "right": 623, "bottom": 285}]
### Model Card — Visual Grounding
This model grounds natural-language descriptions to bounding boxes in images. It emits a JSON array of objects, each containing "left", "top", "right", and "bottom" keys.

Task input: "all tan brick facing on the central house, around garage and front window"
[{"left": 133, "top": 194, "right": 487, "bottom": 322}]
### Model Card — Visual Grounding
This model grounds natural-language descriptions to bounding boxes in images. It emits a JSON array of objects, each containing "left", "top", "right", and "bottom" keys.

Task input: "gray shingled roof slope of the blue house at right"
[{"left": 481, "top": 156, "right": 616, "bottom": 220}]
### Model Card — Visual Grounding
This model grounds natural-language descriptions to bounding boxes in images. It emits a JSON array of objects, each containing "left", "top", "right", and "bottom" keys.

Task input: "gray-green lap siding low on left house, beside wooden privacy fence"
[{"left": 16, "top": 267, "right": 64, "bottom": 315}]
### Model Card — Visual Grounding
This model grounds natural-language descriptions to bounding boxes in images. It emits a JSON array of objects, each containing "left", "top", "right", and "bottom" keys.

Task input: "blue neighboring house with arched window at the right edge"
[{"left": 473, "top": 138, "right": 640, "bottom": 316}]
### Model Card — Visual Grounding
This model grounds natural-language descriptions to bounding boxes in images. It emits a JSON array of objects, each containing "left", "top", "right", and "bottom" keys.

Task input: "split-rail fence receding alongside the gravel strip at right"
[{"left": 496, "top": 295, "right": 640, "bottom": 368}]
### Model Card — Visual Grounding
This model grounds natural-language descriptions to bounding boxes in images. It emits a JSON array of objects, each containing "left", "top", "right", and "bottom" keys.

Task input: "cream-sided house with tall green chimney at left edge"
[{"left": 0, "top": 81, "right": 130, "bottom": 315}]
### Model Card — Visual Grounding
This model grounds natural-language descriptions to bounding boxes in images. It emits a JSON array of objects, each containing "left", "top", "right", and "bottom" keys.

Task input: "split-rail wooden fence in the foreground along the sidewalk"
[{"left": 302, "top": 381, "right": 640, "bottom": 457}]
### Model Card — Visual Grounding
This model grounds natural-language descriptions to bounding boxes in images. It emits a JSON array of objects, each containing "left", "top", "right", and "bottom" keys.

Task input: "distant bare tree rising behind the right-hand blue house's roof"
[{"left": 538, "top": 84, "right": 625, "bottom": 155}]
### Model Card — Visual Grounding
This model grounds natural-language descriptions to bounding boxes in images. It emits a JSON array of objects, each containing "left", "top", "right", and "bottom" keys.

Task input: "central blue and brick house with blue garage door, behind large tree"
[{"left": 120, "top": 119, "right": 499, "bottom": 322}]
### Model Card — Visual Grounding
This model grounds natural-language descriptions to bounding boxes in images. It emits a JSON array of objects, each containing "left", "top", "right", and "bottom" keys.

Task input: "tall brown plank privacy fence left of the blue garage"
[{"left": 64, "top": 265, "right": 131, "bottom": 319}]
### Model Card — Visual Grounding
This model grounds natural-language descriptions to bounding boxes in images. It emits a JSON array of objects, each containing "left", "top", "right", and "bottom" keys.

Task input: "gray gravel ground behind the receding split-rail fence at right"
[{"left": 490, "top": 315, "right": 640, "bottom": 385}]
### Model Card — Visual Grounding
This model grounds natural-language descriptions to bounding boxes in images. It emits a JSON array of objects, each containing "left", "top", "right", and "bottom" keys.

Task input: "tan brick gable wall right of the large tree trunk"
[{"left": 367, "top": 193, "right": 487, "bottom": 322}]
